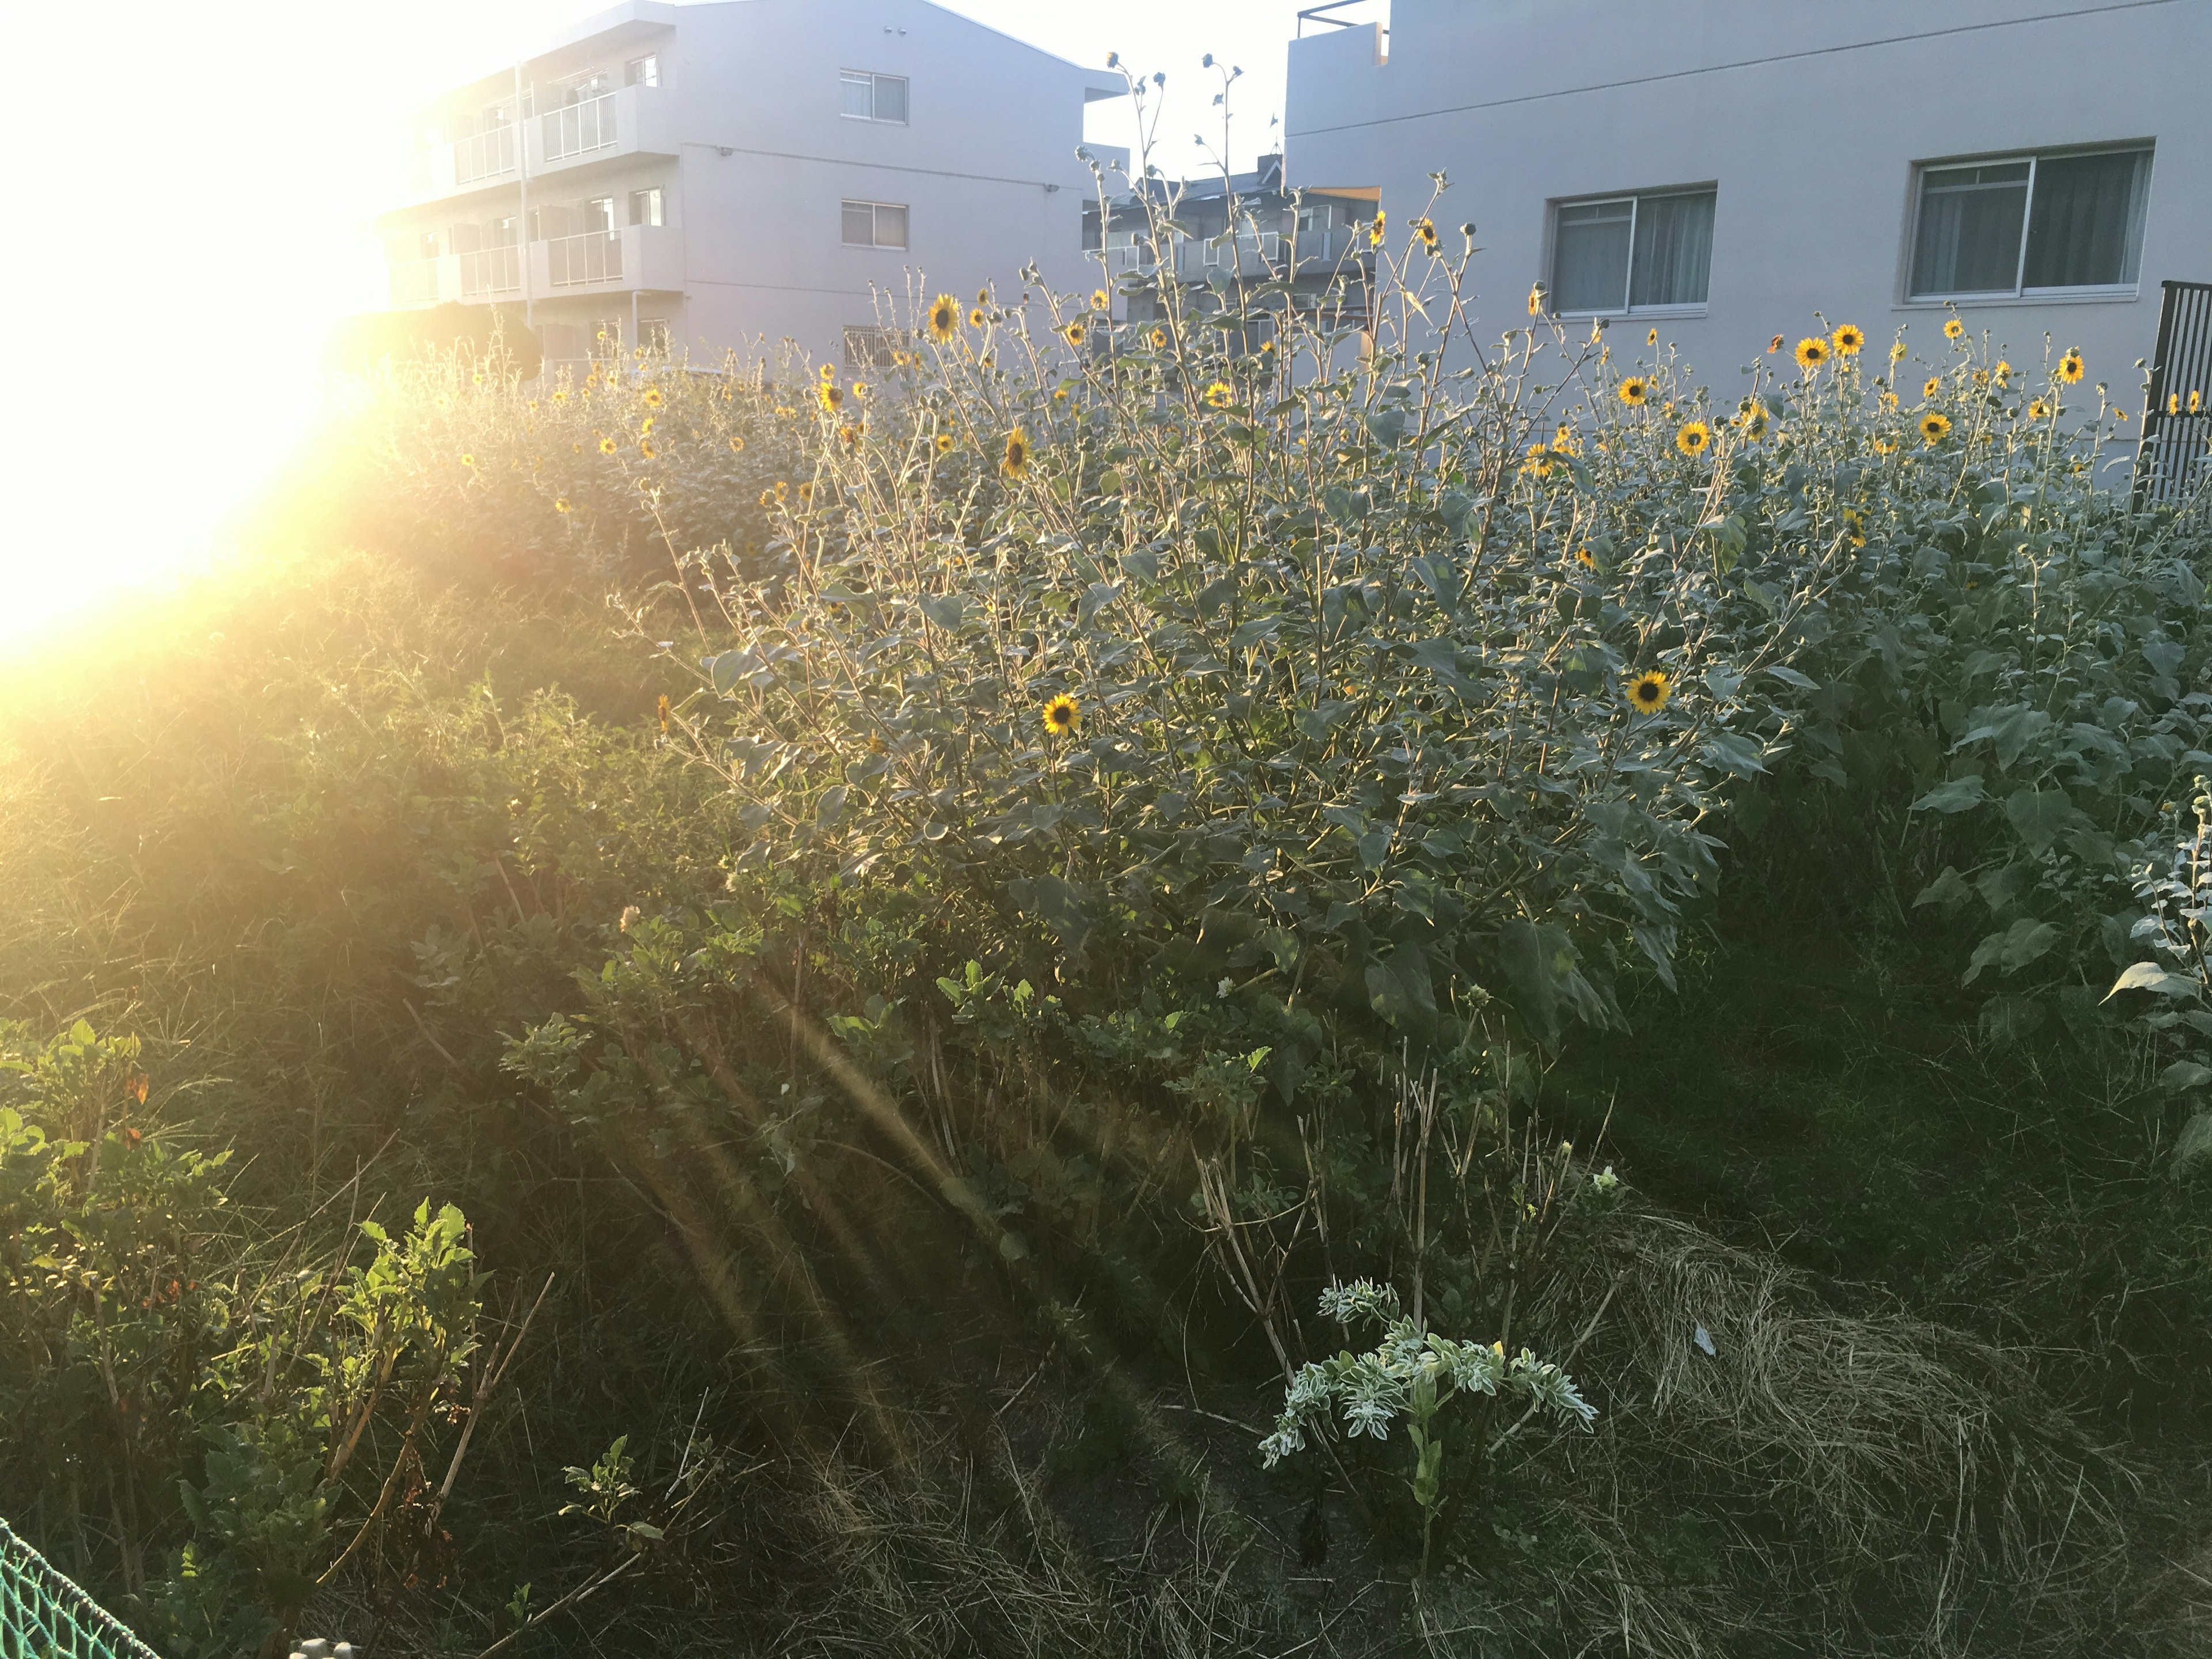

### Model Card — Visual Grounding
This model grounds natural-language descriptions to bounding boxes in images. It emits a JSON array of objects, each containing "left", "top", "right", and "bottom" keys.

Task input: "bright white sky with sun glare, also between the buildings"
[{"left": 0, "top": 0, "right": 1387, "bottom": 655}]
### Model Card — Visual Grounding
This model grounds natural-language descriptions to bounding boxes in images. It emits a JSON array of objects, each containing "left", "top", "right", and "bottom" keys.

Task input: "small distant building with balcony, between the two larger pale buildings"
[{"left": 1084, "top": 155, "right": 1376, "bottom": 323}]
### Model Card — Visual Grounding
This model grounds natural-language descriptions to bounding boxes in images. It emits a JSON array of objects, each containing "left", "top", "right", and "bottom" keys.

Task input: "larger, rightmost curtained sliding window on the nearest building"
[{"left": 1909, "top": 148, "right": 2150, "bottom": 298}]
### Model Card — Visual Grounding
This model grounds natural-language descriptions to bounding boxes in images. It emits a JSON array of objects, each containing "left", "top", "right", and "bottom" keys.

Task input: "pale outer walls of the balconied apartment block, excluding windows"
[{"left": 385, "top": 0, "right": 1119, "bottom": 369}]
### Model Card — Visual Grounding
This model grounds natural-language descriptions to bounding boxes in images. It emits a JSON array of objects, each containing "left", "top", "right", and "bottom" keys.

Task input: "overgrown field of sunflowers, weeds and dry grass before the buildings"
[{"left": 0, "top": 133, "right": 2212, "bottom": 1654}]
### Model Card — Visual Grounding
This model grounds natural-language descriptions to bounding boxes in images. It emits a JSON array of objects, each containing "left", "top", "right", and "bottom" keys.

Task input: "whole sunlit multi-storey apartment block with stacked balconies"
[{"left": 378, "top": 0, "right": 1124, "bottom": 365}]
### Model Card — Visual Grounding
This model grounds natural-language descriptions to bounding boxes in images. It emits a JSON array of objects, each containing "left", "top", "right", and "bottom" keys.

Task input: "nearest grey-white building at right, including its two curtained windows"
[{"left": 1283, "top": 0, "right": 2212, "bottom": 407}]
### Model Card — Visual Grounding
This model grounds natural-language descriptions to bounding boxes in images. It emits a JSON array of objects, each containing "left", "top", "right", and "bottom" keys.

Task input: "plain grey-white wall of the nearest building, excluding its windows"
[{"left": 1285, "top": 0, "right": 2212, "bottom": 400}]
